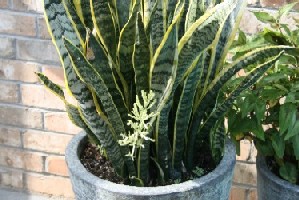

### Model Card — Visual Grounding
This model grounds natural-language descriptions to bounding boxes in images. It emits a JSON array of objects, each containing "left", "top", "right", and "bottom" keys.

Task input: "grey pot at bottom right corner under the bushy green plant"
[{"left": 256, "top": 156, "right": 299, "bottom": 200}]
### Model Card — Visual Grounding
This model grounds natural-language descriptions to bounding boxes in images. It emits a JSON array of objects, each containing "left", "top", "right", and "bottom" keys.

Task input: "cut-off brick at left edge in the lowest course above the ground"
[{"left": 0, "top": 168, "right": 23, "bottom": 189}]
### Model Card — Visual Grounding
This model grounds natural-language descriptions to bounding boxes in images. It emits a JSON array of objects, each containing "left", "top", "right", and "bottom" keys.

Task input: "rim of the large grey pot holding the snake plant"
[{"left": 65, "top": 131, "right": 236, "bottom": 196}]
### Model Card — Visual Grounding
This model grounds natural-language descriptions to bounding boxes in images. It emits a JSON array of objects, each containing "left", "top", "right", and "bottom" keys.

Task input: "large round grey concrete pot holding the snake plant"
[{"left": 65, "top": 133, "right": 236, "bottom": 200}]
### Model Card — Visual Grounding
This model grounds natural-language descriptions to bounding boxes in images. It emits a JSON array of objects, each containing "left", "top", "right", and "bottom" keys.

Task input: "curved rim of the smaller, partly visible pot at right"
[{"left": 256, "top": 154, "right": 299, "bottom": 193}]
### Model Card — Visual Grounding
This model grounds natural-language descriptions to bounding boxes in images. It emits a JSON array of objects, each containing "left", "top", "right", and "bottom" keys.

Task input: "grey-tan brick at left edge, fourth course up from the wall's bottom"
[{"left": 0, "top": 106, "right": 43, "bottom": 129}]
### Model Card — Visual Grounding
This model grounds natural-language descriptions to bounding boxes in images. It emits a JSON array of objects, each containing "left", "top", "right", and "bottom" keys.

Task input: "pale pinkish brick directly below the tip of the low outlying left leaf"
[{"left": 21, "top": 84, "right": 65, "bottom": 110}]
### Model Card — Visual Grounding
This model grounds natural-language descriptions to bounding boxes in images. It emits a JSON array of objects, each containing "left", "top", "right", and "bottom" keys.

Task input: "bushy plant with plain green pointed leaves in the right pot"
[{"left": 228, "top": 3, "right": 299, "bottom": 184}]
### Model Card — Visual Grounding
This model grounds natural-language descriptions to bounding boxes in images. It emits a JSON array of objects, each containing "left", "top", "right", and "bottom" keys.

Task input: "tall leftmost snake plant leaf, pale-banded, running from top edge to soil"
[{"left": 44, "top": 0, "right": 124, "bottom": 177}]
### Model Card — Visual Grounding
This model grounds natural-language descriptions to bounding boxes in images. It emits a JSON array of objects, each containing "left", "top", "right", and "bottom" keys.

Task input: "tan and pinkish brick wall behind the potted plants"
[{"left": 0, "top": 0, "right": 299, "bottom": 200}]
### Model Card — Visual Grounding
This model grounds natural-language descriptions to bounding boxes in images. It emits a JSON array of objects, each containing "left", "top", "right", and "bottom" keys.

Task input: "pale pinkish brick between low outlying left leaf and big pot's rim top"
[{"left": 44, "top": 112, "right": 81, "bottom": 134}]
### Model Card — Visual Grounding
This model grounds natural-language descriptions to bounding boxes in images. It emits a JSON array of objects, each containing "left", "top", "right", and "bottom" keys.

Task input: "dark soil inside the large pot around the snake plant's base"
[{"left": 80, "top": 143, "right": 216, "bottom": 186}]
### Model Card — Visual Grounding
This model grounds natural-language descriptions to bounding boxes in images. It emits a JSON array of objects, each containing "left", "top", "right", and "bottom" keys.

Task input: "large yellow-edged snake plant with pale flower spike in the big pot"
[{"left": 38, "top": 0, "right": 296, "bottom": 186}]
